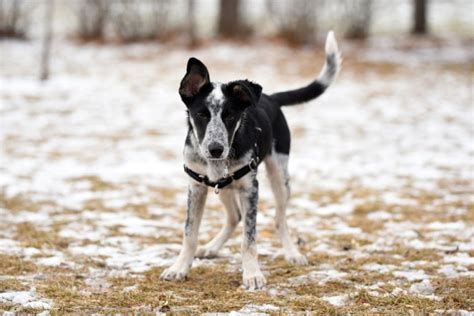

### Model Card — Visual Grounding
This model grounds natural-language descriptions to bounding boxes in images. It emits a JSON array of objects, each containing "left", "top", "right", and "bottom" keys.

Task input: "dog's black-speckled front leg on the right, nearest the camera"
[{"left": 240, "top": 174, "right": 266, "bottom": 290}]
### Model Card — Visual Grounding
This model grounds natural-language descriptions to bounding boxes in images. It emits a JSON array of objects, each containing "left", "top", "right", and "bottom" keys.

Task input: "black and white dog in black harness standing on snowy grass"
[{"left": 161, "top": 32, "right": 341, "bottom": 290}]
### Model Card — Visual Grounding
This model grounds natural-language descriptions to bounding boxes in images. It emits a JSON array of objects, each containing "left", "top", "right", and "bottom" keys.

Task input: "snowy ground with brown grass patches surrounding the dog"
[{"left": 0, "top": 38, "right": 474, "bottom": 313}]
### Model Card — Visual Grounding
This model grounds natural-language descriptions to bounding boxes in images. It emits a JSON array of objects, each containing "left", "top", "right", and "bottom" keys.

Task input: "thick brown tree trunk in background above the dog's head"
[{"left": 218, "top": 0, "right": 242, "bottom": 37}]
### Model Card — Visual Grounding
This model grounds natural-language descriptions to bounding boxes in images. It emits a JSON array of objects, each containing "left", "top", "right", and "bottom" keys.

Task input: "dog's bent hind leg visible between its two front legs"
[{"left": 196, "top": 189, "right": 241, "bottom": 258}]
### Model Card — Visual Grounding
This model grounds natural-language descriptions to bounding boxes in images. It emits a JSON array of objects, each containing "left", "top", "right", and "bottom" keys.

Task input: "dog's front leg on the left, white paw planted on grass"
[{"left": 161, "top": 181, "right": 207, "bottom": 280}]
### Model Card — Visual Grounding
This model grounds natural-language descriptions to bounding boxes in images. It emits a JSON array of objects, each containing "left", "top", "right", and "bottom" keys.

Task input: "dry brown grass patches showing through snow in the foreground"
[{"left": 0, "top": 181, "right": 474, "bottom": 314}]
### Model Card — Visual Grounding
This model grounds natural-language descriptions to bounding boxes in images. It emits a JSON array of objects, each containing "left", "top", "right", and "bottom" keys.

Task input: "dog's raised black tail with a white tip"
[{"left": 270, "top": 31, "right": 342, "bottom": 106}]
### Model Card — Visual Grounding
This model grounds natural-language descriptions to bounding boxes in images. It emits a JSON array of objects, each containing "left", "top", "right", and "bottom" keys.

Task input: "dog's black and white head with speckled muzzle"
[{"left": 179, "top": 58, "right": 262, "bottom": 160}]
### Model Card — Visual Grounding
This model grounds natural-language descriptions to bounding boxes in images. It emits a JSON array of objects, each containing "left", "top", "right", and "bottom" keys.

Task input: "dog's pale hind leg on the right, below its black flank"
[{"left": 265, "top": 151, "right": 308, "bottom": 265}]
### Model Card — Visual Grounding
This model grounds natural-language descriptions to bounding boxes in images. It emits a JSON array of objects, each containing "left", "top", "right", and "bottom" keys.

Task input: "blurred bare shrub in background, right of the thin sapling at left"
[{"left": 75, "top": 0, "right": 111, "bottom": 41}]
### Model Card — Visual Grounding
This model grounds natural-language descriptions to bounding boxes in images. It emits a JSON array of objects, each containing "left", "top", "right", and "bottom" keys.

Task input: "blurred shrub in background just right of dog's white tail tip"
[{"left": 342, "top": 0, "right": 372, "bottom": 39}]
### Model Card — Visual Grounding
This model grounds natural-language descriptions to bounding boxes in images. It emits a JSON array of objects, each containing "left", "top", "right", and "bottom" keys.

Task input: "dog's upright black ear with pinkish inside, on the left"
[{"left": 179, "top": 57, "right": 211, "bottom": 104}]
